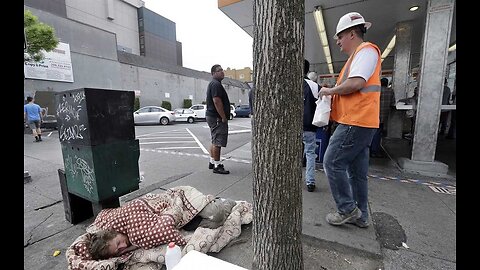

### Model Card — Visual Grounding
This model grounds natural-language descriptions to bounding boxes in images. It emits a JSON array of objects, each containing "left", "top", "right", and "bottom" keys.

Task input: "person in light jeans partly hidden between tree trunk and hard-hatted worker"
[{"left": 303, "top": 59, "right": 318, "bottom": 192}]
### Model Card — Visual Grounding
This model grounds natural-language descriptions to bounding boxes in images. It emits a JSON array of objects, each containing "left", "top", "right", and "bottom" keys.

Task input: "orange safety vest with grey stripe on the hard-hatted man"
[{"left": 330, "top": 42, "right": 382, "bottom": 128}]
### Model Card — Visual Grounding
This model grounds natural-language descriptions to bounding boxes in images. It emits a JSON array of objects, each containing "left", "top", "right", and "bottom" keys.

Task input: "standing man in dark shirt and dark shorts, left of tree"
[{"left": 205, "top": 64, "right": 230, "bottom": 174}]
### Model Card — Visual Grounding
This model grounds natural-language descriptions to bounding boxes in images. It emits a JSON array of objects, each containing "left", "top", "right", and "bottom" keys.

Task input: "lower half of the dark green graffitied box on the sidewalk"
[{"left": 61, "top": 139, "right": 140, "bottom": 203}]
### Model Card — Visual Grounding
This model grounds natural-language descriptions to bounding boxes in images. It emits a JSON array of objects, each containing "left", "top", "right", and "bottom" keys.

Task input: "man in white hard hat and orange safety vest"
[{"left": 320, "top": 12, "right": 381, "bottom": 228}]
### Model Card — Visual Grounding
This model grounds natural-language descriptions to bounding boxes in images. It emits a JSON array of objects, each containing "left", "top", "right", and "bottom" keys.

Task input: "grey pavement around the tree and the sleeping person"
[{"left": 24, "top": 135, "right": 456, "bottom": 270}]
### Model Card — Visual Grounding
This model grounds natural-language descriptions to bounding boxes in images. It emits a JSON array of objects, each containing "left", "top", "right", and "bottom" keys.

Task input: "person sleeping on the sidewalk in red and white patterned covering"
[{"left": 85, "top": 195, "right": 235, "bottom": 260}]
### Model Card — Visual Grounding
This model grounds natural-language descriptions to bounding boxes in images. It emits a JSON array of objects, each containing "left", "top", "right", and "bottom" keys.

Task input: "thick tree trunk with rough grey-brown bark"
[{"left": 252, "top": 0, "right": 305, "bottom": 270}]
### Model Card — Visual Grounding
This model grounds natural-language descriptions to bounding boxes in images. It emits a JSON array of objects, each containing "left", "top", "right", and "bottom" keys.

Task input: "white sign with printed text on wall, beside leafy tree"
[{"left": 23, "top": 42, "right": 73, "bottom": 82}]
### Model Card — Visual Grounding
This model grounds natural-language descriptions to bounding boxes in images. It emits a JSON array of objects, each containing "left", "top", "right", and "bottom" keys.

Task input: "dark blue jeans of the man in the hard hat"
[{"left": 323, "top": 124, "right": 377, "bottom": 221}]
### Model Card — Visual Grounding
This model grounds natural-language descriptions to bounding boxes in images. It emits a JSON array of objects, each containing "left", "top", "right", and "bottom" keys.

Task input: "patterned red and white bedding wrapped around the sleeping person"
[{"left": 66, "top": 186, "right": 253, "bottom": 270}]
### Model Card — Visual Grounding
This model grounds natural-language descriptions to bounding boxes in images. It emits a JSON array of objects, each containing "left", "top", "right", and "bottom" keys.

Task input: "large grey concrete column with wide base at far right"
[{"left": 400, "top": 0, "right": 455, "bottom": 175}]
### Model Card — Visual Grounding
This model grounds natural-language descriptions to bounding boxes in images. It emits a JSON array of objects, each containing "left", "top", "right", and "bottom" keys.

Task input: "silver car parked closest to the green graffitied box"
[{"left": 133, "top": 106, "right": 175, "bottom": 125}]
